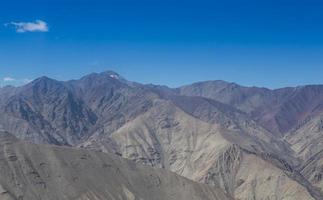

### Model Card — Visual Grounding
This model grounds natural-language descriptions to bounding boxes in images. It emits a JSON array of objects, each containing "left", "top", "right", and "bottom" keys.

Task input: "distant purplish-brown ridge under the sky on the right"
[{"left": 178, "top": 81, "right": 323, "bottom": 136}]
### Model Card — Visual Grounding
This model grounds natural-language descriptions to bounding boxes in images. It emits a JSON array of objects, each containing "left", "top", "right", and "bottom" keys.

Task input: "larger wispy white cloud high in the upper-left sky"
[{"left": 5, "top": 20, "right": 49, "bottom": 33}]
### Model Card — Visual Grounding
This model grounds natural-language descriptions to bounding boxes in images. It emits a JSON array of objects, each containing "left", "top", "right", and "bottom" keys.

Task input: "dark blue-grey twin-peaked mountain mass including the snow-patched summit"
[{"left": 0, "top": 72, "right": 156, "bottom": 145}]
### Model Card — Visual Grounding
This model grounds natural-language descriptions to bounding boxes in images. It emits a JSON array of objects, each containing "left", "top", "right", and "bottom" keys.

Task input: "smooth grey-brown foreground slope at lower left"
[{"left": 0, "top": 132, "right": 230, "bottom": 200}]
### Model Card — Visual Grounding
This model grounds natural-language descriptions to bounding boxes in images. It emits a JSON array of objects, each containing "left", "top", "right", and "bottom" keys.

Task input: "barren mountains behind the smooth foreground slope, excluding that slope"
[{"left": 0, "top": 71, "right": 323, "bottom": 200}]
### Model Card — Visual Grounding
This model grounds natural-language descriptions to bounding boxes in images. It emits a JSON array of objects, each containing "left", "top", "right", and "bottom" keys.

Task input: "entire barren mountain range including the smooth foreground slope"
[{"left": 0, "top": 71, "right": 323, "bottom": 200}]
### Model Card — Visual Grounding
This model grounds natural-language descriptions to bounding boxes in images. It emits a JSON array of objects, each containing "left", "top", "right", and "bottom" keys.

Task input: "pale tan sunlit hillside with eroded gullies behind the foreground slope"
[{"left": 83, "top": 101, "right": 321, "bottom": 200}]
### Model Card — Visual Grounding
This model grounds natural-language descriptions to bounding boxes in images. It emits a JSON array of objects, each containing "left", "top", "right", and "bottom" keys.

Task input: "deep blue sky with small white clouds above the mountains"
[{"left": 0, "top": 0, "right": 323, "bottom": 88}]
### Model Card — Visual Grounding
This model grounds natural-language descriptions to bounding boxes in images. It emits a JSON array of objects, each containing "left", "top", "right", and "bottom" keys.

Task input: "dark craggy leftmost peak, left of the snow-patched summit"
[{"left": 0, "top": 77, "right": 97, "bottom": 144}]
